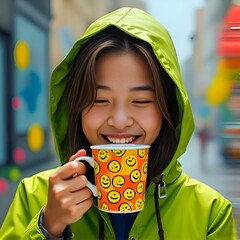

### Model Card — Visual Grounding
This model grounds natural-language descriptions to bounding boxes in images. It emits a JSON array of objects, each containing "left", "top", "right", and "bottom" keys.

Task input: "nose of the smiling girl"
[{"left": 108, "top": 106, "right": 134, "bottom": 129}]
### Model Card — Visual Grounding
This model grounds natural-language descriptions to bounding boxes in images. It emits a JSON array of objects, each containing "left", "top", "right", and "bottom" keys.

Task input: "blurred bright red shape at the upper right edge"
[{"left": 217, "top": 5, "right": 240, "bottom": 58}]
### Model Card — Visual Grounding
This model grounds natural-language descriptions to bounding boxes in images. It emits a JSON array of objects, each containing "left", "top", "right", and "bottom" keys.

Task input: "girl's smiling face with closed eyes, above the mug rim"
[{"left": 82, "top": 53, "right": 162, "bottom": 145}]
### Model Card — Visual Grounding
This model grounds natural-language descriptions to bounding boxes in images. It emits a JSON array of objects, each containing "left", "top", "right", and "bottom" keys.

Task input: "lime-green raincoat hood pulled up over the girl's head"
[{"left": 49, "top": 7, "right": 194, "bottom": 184}]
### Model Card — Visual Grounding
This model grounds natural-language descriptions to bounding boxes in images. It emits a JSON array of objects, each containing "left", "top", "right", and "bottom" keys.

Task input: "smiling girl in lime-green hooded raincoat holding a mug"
[{"left": 0, "top": 8, "right": 236, "bottom": 240}]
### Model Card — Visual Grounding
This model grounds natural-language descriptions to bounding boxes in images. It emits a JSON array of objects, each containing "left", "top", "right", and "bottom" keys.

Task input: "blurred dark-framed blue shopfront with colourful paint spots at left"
[{"left": 0, "top": 0, "right": 52, "bottom": 193}]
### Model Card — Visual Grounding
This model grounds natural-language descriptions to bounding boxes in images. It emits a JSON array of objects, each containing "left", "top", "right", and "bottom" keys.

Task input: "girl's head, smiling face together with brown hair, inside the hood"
[{"left": 67, "top": 26, "right": 178, "bottom": 180}]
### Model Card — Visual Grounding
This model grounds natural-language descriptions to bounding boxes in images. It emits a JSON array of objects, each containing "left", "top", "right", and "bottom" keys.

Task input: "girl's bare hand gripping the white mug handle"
[{"left": 43, "top": 150, "right": 93, "bottom": 237}]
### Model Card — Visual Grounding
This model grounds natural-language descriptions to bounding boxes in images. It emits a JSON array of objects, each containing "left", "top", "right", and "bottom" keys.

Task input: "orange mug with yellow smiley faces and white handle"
[{"left": 76, "top": 144, "right": 150, "bottom": 213}]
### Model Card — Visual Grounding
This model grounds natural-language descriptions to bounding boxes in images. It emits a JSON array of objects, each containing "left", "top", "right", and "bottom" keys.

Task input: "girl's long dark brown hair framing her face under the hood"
[{"left": 66, "top": 27, "right": 179, "bottom": 182}]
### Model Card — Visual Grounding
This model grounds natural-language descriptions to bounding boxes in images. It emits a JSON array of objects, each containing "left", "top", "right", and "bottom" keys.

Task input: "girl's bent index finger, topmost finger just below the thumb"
[{"left": 50, "top": 161, "right": 87, "bottom": 183}]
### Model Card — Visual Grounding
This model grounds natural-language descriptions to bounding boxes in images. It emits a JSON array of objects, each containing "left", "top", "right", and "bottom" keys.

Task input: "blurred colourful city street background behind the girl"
[{"left": 0, "top": 0, "right": 240, "bottom": 236}]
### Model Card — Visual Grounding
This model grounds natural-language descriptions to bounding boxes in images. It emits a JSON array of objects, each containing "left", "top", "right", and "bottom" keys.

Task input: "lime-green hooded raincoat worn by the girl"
[{"left": 0, "top": 8, "right": 236, "bottom": 240}]
